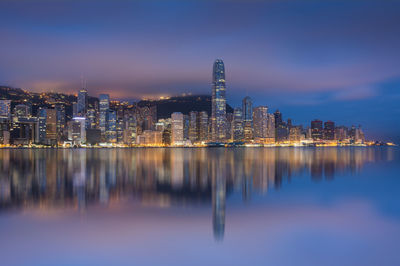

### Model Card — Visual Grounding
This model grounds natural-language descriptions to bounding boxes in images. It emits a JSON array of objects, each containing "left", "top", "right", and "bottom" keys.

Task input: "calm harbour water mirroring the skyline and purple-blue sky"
[{"left": 0, "top": 147, "right": 400, "bottom": 265}]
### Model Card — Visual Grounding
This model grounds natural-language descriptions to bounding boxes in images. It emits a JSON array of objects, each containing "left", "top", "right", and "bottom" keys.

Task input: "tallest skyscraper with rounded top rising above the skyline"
[{"left": 211, "top": 59, "right": 226, "bottom": 141}]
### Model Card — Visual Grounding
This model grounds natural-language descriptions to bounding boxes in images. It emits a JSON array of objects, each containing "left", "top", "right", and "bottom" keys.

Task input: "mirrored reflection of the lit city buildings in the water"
[{"left": 0, "top": 147, "right": 393, "bottom": 239}]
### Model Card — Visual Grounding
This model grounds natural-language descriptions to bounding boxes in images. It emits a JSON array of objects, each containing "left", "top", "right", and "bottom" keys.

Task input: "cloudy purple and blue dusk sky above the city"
[{"left": 0, "top": 0, "right": 400, "bottom": 142}]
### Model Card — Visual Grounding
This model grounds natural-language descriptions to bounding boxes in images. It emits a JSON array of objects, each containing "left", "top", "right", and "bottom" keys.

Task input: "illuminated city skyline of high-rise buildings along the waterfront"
[{"left": 0, "top": 59, "right": 372, "bottom": 147}]
